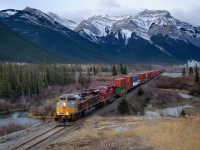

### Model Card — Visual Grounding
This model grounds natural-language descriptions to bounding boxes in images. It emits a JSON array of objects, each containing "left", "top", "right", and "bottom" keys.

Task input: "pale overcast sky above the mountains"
[{"left": 0, "top": 0, "right": 200, "bottom": 26}]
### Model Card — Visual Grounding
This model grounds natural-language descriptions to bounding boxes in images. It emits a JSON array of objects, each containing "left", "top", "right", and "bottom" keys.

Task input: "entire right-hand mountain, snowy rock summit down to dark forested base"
[{"left": 75, "top": 10, "right": 200, "bottom": 62}]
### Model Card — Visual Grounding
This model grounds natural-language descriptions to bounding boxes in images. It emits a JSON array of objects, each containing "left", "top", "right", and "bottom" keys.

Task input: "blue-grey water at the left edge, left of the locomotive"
[{"left": 0, "top": 111, "right": 41, "bottom": 125}]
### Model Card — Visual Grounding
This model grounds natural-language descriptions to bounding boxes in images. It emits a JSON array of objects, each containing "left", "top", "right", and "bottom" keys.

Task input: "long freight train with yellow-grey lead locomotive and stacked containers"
[{"left": 55, "top": 69, "right": 162, "bottom": 124}]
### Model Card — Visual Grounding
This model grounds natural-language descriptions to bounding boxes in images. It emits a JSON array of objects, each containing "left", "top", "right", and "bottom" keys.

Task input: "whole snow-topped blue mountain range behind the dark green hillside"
[{"left": 0, "top": 7, "right": 200, "bottom": 63}]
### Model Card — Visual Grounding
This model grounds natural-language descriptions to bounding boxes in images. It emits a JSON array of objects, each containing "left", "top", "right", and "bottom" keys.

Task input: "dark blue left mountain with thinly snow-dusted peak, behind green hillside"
[{"left": 0, "top": 7, "right": 120, "bottom": 63}]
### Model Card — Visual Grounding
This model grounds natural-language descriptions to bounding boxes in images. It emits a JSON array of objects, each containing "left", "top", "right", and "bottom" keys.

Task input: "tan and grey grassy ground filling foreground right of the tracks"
[{"left": 45, "top": 115, "right": 200, "bottom": 150}]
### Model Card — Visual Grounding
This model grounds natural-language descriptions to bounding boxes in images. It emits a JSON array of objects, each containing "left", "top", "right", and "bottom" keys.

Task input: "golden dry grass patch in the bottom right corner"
[{"left": 133, "top": 119, "right": 200, "bottom": 150}]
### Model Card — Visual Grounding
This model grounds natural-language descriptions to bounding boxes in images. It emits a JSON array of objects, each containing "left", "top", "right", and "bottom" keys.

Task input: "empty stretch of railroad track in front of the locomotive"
[{"left": 11, "top": 126, "right": 65, "bottom": 150}]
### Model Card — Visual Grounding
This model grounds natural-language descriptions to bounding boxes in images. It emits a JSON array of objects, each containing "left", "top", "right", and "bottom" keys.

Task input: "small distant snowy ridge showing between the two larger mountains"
[{"left": 47, "top": 12, "right": 78, "bottom": 30}]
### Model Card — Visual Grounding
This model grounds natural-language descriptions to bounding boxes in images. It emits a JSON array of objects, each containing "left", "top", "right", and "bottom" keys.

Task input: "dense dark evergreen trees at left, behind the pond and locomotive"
[{"left": 0, "top": 63, "right": 76, "bottom": 102}]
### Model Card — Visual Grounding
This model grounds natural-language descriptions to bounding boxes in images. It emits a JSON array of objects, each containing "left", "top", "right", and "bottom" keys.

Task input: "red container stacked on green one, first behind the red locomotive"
[{"left": 113, "top": 78, "right": 126, "bottom": 93}]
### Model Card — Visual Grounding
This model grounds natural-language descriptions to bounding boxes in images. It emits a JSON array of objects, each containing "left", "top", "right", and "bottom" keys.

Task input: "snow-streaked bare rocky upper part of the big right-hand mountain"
[{"left": 75, "top": 10, "right": 200, "bottom": 46}]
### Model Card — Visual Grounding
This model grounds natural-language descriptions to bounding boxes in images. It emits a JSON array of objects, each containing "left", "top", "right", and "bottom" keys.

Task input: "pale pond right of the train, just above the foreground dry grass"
[{"left": 145, "top": 105, "right": 193, "bottom": 117}]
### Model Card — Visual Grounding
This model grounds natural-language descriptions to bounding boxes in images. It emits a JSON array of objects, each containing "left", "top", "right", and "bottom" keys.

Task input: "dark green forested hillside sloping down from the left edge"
[{"left": 0, "top": 22, "right": 70, "bottom": 63}]
